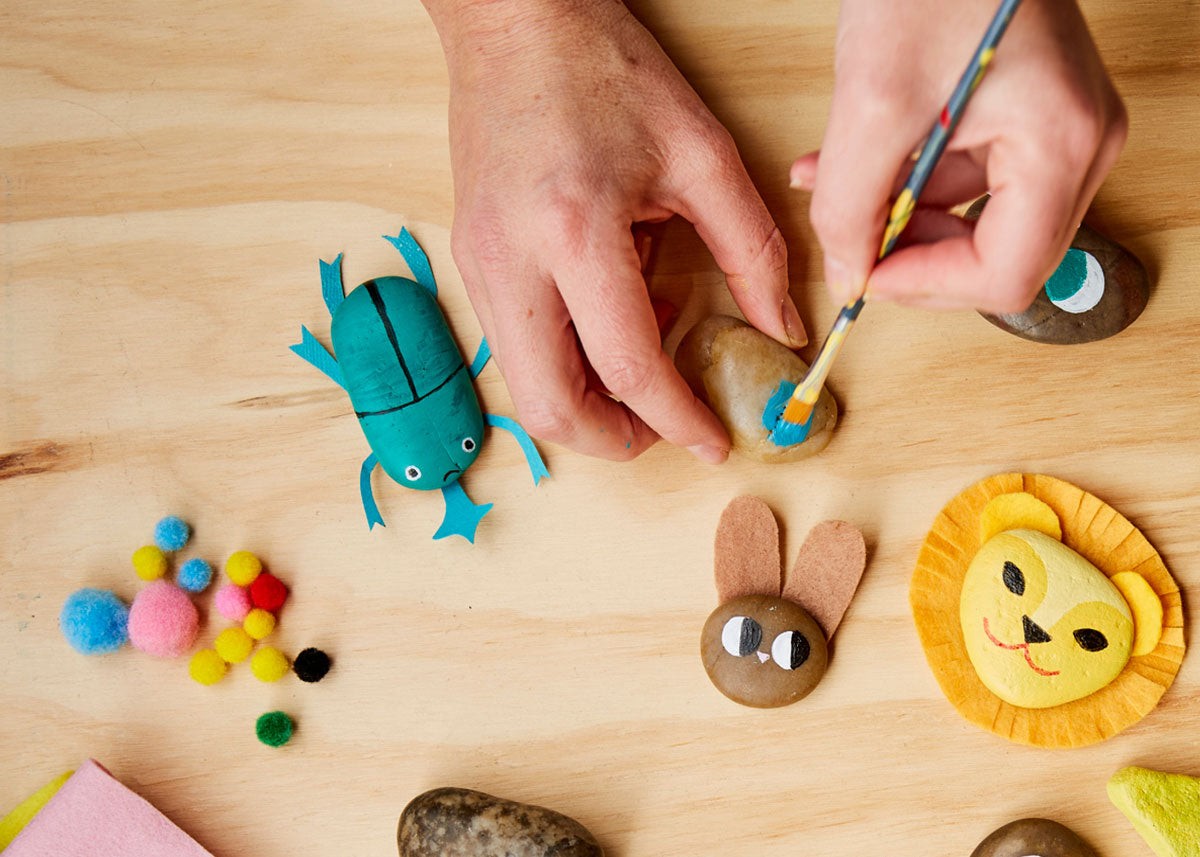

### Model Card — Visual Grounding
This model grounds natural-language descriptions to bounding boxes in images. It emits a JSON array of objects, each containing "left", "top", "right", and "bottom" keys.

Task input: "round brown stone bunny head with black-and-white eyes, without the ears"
[{"left": 700, "top": 595, "right": 829, "bottom": 708}]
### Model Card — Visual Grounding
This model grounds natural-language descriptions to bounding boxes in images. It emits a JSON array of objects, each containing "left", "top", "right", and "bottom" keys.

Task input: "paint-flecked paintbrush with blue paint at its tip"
[{"left": 762, "top": 0, "right": 1021, "bottom": 447}]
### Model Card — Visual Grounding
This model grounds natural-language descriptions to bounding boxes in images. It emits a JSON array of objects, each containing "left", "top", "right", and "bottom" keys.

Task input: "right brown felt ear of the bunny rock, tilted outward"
[{"left": 784, "top": 521, "right": 866, "bottom": 640}]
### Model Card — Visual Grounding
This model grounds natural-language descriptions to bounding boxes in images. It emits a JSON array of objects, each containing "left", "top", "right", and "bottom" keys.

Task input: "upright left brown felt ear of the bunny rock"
[{"left": 713, "top": 496, "right": 784, "bottom": 604}]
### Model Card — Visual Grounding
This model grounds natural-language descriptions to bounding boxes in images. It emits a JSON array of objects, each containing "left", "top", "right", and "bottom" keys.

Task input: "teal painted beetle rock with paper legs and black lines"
[{"left": 292, "top": 229, "right": 550, "bottom": 541}]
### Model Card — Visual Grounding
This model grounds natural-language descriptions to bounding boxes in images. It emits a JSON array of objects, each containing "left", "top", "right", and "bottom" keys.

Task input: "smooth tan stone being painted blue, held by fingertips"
[{"left": 676, "top": 316, "right": 838, "bottom": 463}]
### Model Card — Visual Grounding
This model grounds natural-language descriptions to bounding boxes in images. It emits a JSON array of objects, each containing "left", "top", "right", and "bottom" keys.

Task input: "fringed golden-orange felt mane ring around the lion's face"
[{"left": 908, "top": 473, "right": 1184, "bottom": 748}]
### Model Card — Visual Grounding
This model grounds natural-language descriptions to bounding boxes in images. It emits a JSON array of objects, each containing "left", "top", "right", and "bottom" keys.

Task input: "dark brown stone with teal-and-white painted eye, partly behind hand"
[{"left": 966, "top": 200, "right": 1150, "bottom": 344}]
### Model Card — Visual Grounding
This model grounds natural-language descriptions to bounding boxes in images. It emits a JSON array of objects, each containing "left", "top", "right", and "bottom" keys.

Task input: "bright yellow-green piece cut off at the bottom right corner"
[{"left": 1108, "top": 767, "right": 1200, "bottom": 857}]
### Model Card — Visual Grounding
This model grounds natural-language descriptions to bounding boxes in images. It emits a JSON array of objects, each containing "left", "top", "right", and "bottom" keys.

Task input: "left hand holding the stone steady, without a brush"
[{"left": 425, "top": 0, "right": 806, "bottom": 462}]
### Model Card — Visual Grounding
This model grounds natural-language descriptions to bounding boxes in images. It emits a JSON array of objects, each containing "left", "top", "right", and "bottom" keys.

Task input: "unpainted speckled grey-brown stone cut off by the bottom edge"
[{"left": 396, "top": 787, "right": 604, "bottom": 857}]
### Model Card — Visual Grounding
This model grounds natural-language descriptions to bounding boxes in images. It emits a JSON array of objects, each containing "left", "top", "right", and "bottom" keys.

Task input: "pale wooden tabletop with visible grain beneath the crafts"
[{"left": 0, "top": 0, "right": 1200, "bottom": 857}]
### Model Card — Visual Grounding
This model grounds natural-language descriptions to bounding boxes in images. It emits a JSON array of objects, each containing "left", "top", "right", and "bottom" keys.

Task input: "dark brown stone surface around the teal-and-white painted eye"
[{"left": 966, "top": 200, "right": 1150, "bottom": 344}]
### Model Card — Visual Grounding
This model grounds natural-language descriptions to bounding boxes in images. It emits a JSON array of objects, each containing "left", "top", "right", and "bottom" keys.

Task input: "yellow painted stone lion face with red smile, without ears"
[{"left": 959, "top": 529, "right": 1134, "bottom": 708}]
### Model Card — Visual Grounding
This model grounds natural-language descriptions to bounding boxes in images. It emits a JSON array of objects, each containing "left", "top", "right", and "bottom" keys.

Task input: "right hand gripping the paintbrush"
[{"left": 792, "top": 0, "right": 1127, "bottom": 312}]
